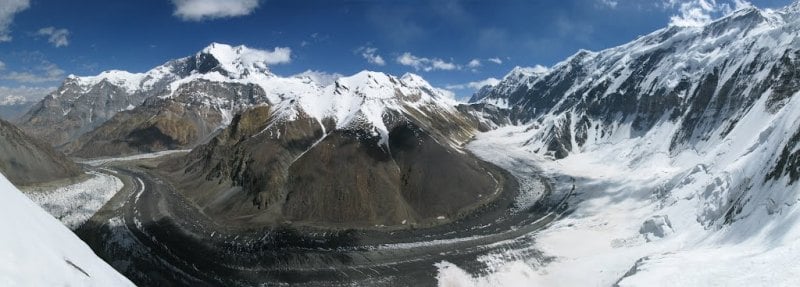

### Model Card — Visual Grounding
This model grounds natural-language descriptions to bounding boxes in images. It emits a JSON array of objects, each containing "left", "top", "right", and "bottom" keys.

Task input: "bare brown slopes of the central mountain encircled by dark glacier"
[{"left": 161, "top": 102, "right": 505, "bottom": 228}]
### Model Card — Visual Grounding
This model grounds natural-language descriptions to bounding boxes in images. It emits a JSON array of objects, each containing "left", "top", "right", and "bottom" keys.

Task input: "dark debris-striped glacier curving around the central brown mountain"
[{"left": 70, "top": 147, "right": 572, "bottom": 286}]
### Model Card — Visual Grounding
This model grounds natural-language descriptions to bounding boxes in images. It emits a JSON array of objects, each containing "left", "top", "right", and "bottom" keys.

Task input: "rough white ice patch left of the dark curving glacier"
[{"left": 26, "top": 172, "right": 123, "bottom": 230}]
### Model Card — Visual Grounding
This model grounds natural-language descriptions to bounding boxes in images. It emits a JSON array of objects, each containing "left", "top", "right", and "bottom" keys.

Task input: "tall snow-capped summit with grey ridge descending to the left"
[{"left": 17, "top": 43, "right": 286, "bottom": 148}]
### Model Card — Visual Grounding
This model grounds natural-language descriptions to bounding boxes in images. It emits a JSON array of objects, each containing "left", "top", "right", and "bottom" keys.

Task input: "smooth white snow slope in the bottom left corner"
[{"left": 0, "top": 172, "right": 133, "bottom": 286}]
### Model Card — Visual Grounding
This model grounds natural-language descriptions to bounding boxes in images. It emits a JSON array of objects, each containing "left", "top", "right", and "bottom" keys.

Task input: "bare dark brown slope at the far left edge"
[{"left": 0, "top": 120, "right": 82, "bottom": 186}]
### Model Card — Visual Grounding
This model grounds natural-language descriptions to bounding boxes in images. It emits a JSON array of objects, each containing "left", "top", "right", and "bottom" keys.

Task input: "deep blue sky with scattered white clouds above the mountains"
[{"left": 0, "top": 0, "right": 791, "bottom": 100}]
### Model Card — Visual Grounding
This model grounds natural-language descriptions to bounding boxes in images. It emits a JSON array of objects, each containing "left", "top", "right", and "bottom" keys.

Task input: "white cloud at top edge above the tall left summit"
[{"left": 172, "top": 0, "right": 259, "bottom": 21}]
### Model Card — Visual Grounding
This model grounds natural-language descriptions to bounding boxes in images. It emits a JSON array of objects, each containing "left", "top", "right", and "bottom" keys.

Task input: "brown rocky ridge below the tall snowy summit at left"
[{"left": 64, "top": 81, "right": 266, "bottom": 158}]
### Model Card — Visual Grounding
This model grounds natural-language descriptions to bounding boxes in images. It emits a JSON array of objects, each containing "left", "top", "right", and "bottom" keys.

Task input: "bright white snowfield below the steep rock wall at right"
[{"left": 439, "top": 106, "right": 800, "bottom": 286}]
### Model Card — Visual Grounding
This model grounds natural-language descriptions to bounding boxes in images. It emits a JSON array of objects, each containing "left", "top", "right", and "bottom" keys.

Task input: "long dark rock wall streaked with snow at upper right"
[{"left": 468, "top": 3, "right": 800, "bottom": 111}]
